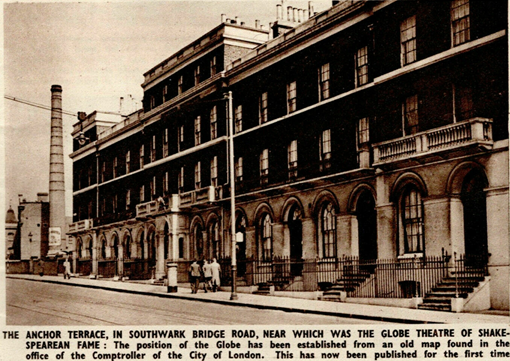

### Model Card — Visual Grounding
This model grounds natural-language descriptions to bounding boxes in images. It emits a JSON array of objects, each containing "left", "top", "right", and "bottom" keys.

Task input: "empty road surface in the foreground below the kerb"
[{"left": 6, "top": 278, "right": 386, "bottom": 326}]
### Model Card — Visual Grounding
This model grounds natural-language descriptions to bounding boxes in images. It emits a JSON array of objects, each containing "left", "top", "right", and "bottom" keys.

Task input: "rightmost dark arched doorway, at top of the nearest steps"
[{"left": 461, "top": 171, "right": 488, "bottom": 265}]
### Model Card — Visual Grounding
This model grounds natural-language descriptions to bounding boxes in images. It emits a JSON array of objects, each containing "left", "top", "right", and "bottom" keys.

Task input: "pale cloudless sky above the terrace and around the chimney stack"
[{"left": 0, "top": 0, "right": 331, "bottom": 216}]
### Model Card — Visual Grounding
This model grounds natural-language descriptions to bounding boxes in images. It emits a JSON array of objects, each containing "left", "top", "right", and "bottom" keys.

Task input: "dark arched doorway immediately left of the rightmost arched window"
[{"left": 356, "top": 190, "right": 377, "bottom": 262}]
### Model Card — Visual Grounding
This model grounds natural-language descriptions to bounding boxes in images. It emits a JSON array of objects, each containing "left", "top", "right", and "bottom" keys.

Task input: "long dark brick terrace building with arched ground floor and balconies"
[{"left": 69, "top": 0, "right": 509, "bottom": 311}]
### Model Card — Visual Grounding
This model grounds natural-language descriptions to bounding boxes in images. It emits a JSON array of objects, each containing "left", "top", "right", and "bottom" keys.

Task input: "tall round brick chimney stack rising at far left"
[{"left": 49, "top": 85, "right": 66, "bottom": 254}]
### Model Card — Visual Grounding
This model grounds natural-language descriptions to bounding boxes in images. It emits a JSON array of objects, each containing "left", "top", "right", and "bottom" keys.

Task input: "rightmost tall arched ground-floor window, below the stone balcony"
[{"left": 401, "top": 185, "right": 424, "bottom": 253}]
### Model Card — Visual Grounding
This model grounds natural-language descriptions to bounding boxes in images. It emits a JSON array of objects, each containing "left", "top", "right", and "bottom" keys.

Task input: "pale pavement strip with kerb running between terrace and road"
[{"left": 7, "top": 274, "right": 510, "bottom": 324}]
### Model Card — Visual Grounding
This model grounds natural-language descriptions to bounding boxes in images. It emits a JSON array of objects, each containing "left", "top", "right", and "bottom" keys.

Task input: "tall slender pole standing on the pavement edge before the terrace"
[{"left": 225, "top": 91, "right": 237, "bottom": 300}]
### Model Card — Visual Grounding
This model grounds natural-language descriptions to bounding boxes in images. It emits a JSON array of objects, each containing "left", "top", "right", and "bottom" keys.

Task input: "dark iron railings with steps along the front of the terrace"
[{"left": 208, "top": 252, "right": 488, "bottom": 298}]
